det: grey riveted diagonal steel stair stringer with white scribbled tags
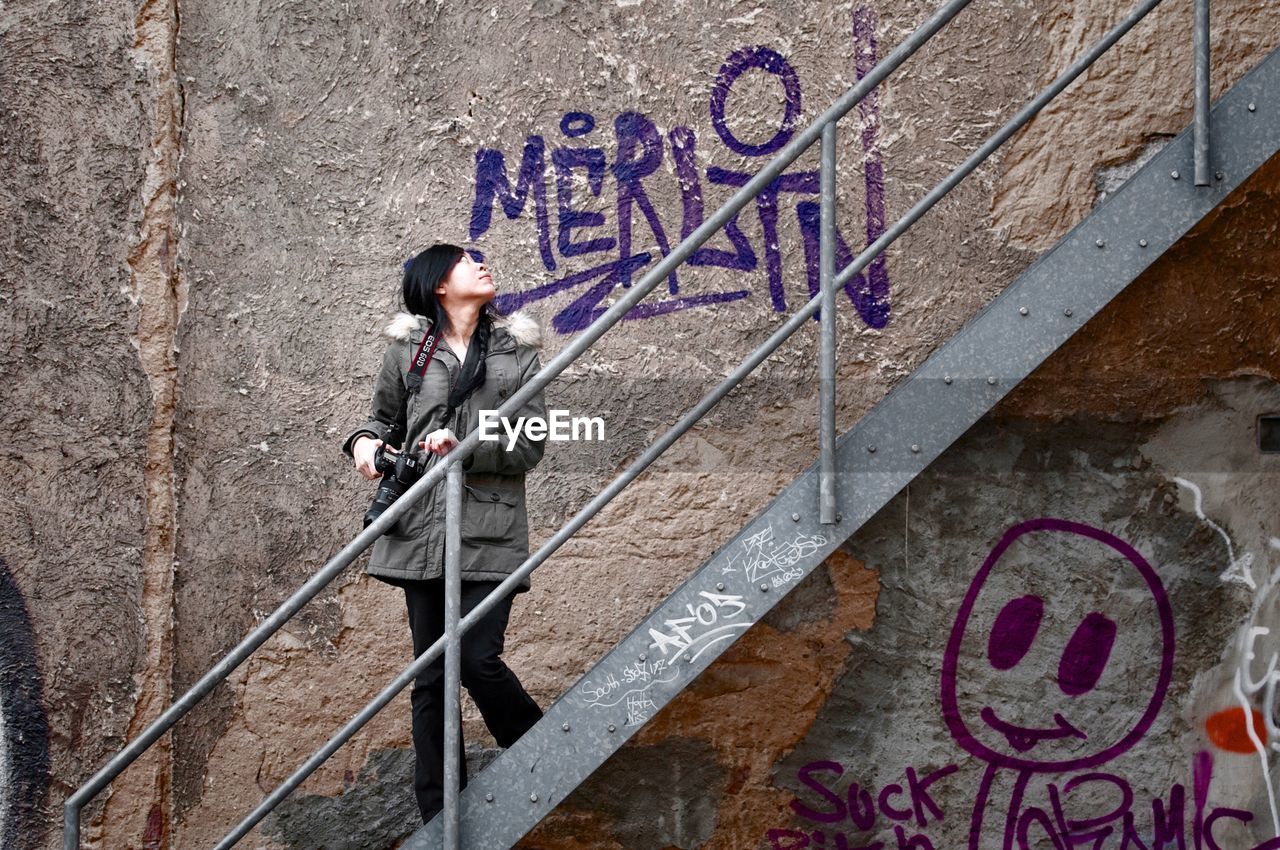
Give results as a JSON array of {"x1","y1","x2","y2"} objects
[{"x1": 403, "y1": 51, "x2": 1280, "y2": 850}]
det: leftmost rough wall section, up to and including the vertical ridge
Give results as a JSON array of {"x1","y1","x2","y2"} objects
[{"x1": 0, "y1": 3, "x2": 177, "y2": 846}]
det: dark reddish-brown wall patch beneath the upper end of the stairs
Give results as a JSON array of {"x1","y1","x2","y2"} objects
[{"x1": 998, "y1": 157, "x2": 1280, "y2": 419}]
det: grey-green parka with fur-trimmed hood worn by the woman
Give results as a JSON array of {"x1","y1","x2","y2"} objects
[{"x1": 342, "y1": 312, "x2": 547, "y2": 588}]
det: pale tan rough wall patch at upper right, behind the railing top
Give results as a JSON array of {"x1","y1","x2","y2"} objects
[{"x1": 991, "y1": 0, "x2": 1280, "y2": 251}]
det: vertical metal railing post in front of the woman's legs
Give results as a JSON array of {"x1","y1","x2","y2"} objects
[{"x1": 444, "y1": 461, "x2": 462, "y2": 850}]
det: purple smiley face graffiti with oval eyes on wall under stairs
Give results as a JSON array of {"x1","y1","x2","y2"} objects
[{"x1": 941, "y1": 518, "x2": 1174, "y2": 773}]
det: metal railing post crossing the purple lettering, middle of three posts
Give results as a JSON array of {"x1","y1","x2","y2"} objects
[{"x1": 818, "y1": 120, "x2": 836, "y2": 525}]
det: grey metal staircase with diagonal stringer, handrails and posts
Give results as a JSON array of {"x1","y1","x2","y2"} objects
[{"x1": 64, "y1": 0, "x2": 1280, "y2": 850}]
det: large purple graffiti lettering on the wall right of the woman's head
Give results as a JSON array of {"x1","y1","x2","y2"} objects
[{"x1": 470, "y1": 9, "x2": 890, "y2": 334}]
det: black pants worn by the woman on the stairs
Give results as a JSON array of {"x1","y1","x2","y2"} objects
[{"x1": 404, "y1": 579, "x2": 543, "y2": 823}]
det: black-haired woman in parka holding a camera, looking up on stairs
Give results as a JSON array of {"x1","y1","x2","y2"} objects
[{"x1": 343, "y1": 245, "x2": 547, "y2": 823}]
